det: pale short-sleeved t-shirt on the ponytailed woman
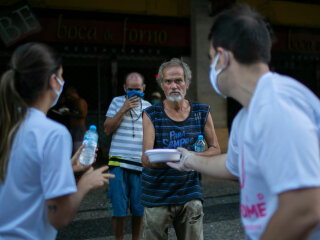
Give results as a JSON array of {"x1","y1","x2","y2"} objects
[{"x1": 0, "y1": 108, "x2": 77, "y2": 240}]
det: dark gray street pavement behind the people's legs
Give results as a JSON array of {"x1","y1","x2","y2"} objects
[{"x1": 57, "y1": 176, "x2": 245, "y2": 240}]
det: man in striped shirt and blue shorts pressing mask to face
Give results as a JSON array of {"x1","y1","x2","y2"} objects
[{"x1": 104, "y1": 72, "x2": 151, "y2": 240}]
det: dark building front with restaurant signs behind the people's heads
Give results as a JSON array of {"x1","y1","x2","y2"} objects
[{"x1": 0, "y1": 0, "x2": 320, "y2": 154}]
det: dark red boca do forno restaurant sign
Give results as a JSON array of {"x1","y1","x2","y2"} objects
[{"x1": 31, "y1": 14, "x2": 190, "y2": 48}]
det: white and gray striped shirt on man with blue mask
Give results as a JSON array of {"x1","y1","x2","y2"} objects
[{"x1": 106, "y1": 96, "x2": 151, "y2": 171}]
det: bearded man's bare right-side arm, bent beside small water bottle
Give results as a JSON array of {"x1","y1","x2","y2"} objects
[{"x1": 197, "y1": 113, "x2": 221, "y2": 156}]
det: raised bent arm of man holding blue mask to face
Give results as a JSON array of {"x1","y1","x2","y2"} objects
[{"x1": 103, "y1": 96, "x2": 141, "y2": 135}]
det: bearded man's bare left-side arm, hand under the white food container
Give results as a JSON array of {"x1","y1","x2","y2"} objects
[{"x1": 141, "y1": 113, "x2": 167, "y2": 168}]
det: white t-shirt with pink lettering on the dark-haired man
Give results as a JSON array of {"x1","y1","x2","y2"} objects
[{"x1": 226, "y1": 72, "x2": 320, "y2": 239}]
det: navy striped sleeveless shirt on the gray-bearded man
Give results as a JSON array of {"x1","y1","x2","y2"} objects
[{"x1": 141, "y1": 101, "x2": 210, "y2": 207}]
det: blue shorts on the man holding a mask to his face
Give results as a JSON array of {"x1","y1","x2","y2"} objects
[{"x1": 108, "y1": 167, "x2": 144, "y2": 217}]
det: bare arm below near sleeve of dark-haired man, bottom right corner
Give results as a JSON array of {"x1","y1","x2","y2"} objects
[{"x1": 261, "y1": 188, "x2": 320, "y2": 240}]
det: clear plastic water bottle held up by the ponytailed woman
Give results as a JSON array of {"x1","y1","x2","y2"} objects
[{"x1": 80, "y1": 125, "x2": 98, "y2": 165}]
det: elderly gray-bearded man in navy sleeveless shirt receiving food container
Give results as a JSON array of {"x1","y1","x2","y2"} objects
[{"x1": 141, "y1": 58, "x2": 220, "y2": 240}]
